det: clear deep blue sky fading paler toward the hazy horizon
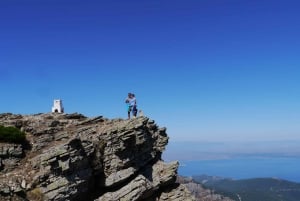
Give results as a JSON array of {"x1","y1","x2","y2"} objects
[{"x1": 0, "y1": 0, "x2": 300, "y2": 144}]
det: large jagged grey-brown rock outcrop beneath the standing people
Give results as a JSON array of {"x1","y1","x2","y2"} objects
[{"x1": 0, "y1": 113, "x2": 194, "y2": 201}]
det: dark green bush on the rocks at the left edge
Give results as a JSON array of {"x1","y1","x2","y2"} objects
[{"x1": 0, "y1": 126, "x2": 26, "y2": 143}]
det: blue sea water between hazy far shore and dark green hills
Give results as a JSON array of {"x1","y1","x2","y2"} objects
[{"x1": 178, "y1": 157, "x2": 300, "y2": 183}]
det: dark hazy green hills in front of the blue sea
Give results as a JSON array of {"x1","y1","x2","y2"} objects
[{"x1": 192, "y1": 175, "x2": 300, "y2": 201}]
